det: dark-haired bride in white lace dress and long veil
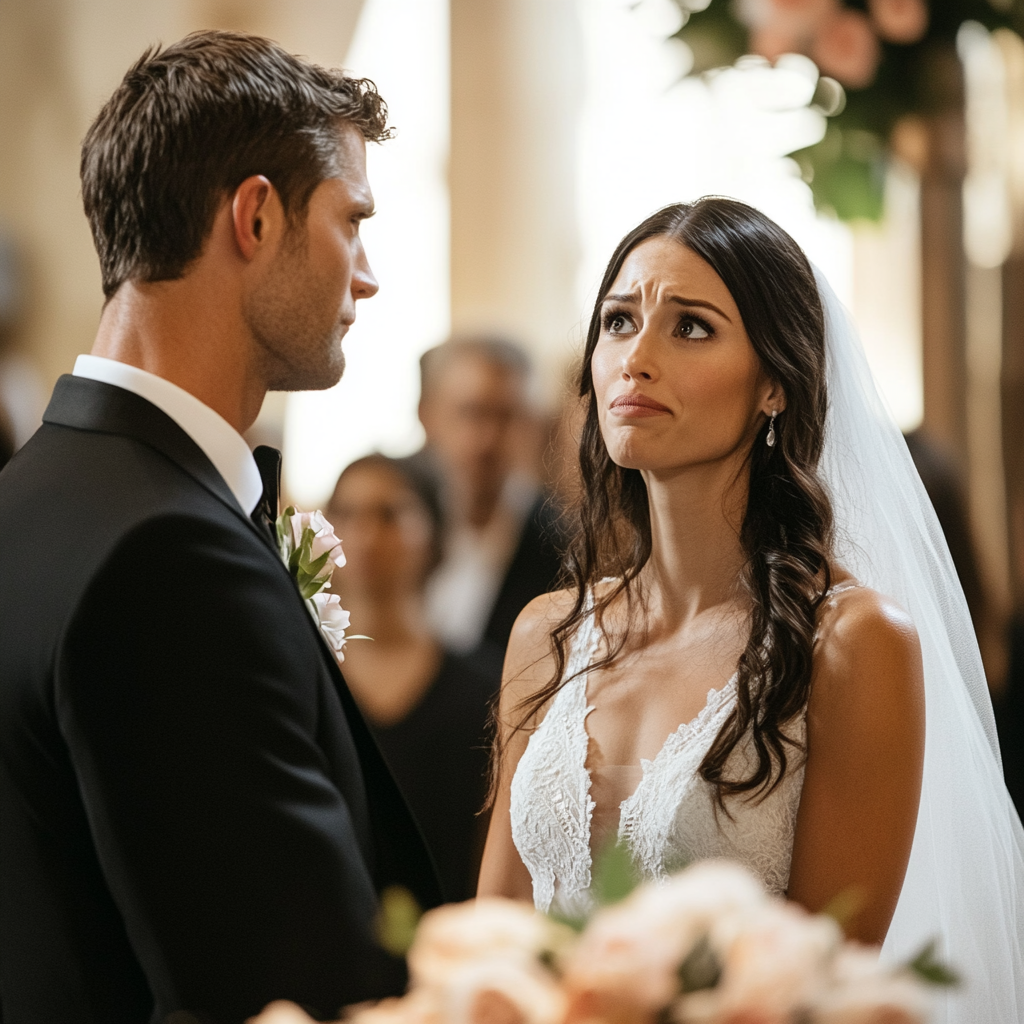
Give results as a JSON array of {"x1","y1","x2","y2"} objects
[{"x1": 479, "y1": 199, "x2": 1024, "y2": 1024}]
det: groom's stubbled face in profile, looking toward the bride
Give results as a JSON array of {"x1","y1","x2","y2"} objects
[{"x1": 244, "y1": 126, "x2": 378, "y2": 391}]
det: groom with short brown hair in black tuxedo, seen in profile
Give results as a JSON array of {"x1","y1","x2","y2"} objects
[{"x1": 0, "y1": 33, "x2": 437, "y2": 1024}]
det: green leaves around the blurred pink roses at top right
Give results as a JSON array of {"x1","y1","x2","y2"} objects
[{"x1": 676, "y1": 0, "x2": 1024, "y2": 220}]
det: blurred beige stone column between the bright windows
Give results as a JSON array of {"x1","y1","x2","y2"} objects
[{"x1": 450, "y1": 0, "x2": 584, "y2": 396}]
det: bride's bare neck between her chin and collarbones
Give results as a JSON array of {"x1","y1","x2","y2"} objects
[{"x1": 643, "y1": 463, "x2": 748, "y2": 620}]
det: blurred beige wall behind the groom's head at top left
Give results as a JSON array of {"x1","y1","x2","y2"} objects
[{"x1": 0, "y1": 0, "x2": 362, "y2": 388}]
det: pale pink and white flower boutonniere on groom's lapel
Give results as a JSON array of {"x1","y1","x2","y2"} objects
[{"x1": 278, "y1": 505, "x2": 362, "y2": 662}]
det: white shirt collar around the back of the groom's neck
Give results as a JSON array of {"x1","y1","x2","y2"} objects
[{"x1": 75, "y1": 355, "x2": 263, "y2": 515}]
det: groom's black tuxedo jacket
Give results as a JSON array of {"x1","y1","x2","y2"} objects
[{"x1": 0, "y1": 377, "x2": 438, "y2": 1024}]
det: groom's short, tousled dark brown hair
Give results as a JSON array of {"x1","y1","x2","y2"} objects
[{"x1": 81, "y1": 32, "x2": 389, "y2": 298}]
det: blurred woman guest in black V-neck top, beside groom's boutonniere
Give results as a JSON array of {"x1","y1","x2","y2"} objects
[{"x1": 327, "y1": 455, "x2": 496, "y2": 900}]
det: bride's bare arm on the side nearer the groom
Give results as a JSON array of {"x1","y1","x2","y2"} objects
[{"x1": 477, "y1": 594, "x2": 565, "y2": 902}]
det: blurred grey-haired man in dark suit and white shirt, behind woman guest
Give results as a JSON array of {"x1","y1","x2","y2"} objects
[{"x1": 416, "y1": 337, "x2": 560, "y2": 674}]
